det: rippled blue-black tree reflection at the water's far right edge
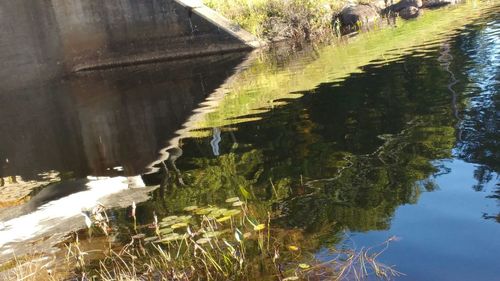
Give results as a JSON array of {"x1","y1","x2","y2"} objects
[{"x1": 456, "y1": 19, "x2": 500, "y2": 221}]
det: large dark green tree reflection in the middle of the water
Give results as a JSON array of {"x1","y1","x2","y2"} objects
[{"x1": 138, "y1": 49, "x2": 459, "y2": 245}]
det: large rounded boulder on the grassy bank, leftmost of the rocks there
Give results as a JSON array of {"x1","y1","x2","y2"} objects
[{"x1": 338, "y1": 4, "x2": 380, "y2": 28}]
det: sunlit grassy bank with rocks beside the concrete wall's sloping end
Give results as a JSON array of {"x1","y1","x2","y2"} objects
[{"x1": 203, "y1": 0, "x2": 459, "y2": 43}]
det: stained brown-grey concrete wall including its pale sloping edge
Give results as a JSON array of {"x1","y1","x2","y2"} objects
[{"x1": 0, "y1": 0, "x2": 260, "y2": 82}]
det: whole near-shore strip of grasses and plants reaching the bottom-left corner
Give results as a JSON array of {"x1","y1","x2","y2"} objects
[{"x1": 0, "y1": 200, "x2": 403, "y2": 281}]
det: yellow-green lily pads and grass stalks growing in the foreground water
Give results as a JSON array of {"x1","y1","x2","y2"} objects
[{"x1": 58, "y1": 197, "x2": 400, "y2": 280}]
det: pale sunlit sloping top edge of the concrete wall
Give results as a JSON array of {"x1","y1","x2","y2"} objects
[{"x1": 174, "y1": 0, "x2": 266, "y2": 49}]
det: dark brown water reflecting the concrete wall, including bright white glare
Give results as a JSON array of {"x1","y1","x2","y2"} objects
[{"x1": 0, "y1": 53, "x2": 246, "y2": 261}]
